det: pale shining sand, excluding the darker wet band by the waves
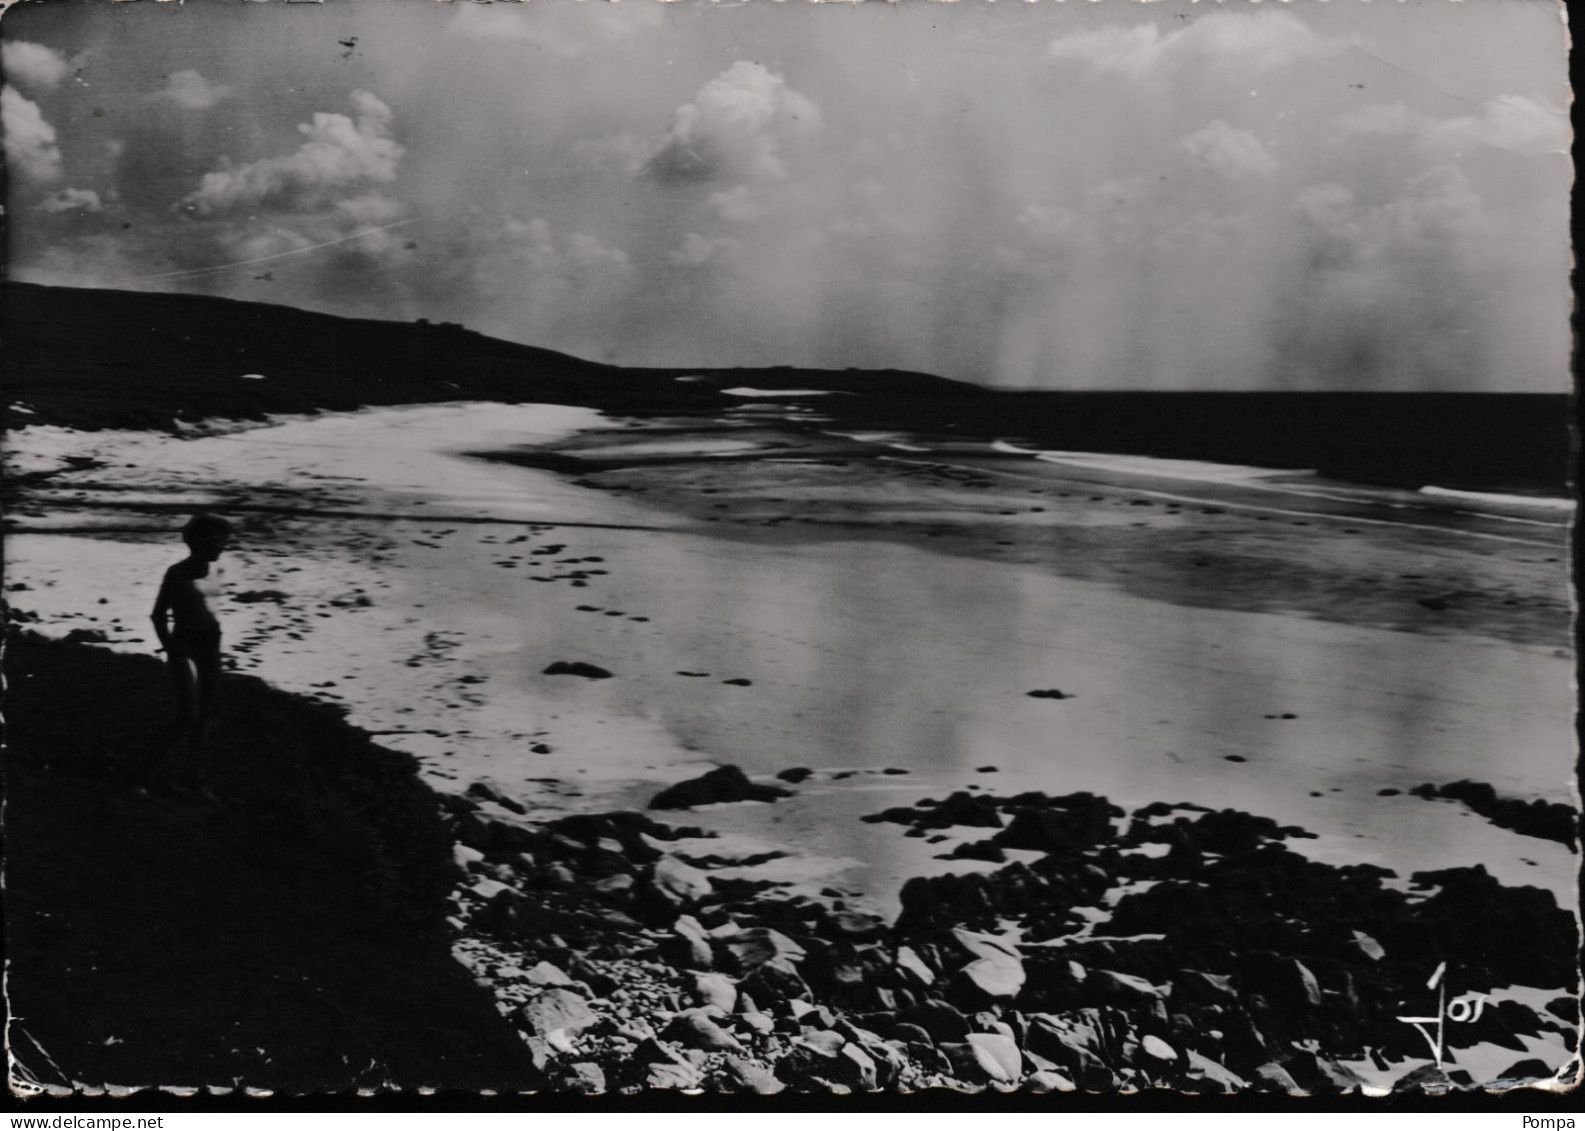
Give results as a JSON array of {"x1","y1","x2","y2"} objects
[{"x1": 8, "y1": 407, "x2": 1572, "y2": 918}]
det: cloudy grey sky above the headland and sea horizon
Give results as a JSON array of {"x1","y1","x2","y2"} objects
[{"x1": 0, "y1": 0, "x2": 1572, "y2": 391}]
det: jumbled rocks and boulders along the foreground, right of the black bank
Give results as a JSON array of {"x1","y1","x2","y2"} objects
[{"x1": 442, "y1": 767, "x2": 1579, "y2": 1095}]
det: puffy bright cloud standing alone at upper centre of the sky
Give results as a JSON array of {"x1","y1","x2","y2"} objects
[{"x1": 647, "y1": 62, "x2": 821, "y2": 181}]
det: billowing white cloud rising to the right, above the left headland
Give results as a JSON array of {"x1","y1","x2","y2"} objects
[{"x1": 181, "y1": 90, "x2": 404, "y2": 217}]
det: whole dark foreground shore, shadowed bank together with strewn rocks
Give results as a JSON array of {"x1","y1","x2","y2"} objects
[{"x1": 5, "y1": 632, "x2": 1579, "y2": 1095}]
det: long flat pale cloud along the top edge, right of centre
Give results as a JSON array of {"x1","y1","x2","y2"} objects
[{"x1": 1046, "y1": 11, "x2": 1342, "y2": 79}]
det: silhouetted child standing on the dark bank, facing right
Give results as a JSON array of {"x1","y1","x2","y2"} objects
[{"x1": 144, "y1": 513, "x2": 231, "y2": 798}]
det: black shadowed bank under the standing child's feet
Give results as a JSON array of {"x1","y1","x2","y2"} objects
[{"x1": 5, "y1": 635, "x2": 537, "y2": 1093}]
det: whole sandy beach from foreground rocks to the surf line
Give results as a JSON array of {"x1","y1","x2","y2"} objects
[{"x1": 10, "y1": 406, "x2": 1574, "y2": 904}]
